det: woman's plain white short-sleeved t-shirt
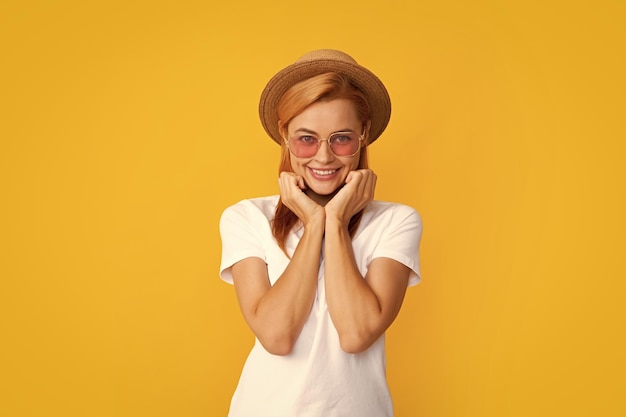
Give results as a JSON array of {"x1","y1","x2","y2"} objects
[{"x1": 220, "y1": 196, "x2": 422, "y2": 417}]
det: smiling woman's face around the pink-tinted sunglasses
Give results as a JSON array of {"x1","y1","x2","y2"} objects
[{"x1": 287, "y1": 99, "x2": 363, "y2": 204}]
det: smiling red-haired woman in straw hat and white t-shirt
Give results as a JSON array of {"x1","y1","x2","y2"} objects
[{"x1": 220, "y1": 50, "x2": 422, "y2": 417}]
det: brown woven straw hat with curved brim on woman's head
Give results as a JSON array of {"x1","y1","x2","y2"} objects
[{"x1": 259, "y1": 49, "x2": 391, "y2": 144}]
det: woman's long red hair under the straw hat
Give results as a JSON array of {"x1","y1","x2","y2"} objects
[{"x1": 272, "y1": 72, "x2": 370, "y2": 257}]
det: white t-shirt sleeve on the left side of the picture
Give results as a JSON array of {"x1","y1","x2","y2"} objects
[{"x1": 220, "y1": 200, "x2": 265, "y2": 284}]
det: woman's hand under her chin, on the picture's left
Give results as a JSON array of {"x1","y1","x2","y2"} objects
[{"x1": 278, "y1": 171, "x2": 326, "y2": 226}]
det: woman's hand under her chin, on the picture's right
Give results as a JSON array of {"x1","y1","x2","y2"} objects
[{"x1": 325, "y1": 169, "x2": 376, "y2": 226}]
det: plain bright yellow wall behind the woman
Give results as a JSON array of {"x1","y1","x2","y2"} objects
[{"x1": 0, "y1": 0, "x2": 626, "y2": 417}]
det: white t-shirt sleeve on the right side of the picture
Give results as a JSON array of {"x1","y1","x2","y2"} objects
[{"x1": 372, "y1": 205, "x2": 422, "y2": 287}]
